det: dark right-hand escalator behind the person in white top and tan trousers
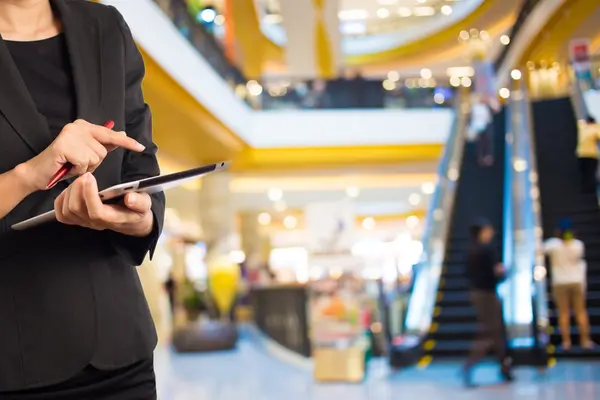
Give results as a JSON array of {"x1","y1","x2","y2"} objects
[{"x1": 532, "y1": 98, "x2": 600, "y2": 358}]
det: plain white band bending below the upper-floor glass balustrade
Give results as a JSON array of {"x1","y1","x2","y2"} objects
[{"x1": 102, "y1": 0, "x2": 452, "y2": 147}]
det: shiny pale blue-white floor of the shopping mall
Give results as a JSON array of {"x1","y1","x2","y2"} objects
[{"x1": 156, "y1": 340, "x2": 600, "y2": 400}]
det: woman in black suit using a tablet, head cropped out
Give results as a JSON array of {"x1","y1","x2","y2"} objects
[{"x1": 0, "y1": 0, "x2": 164, "y2": 400}]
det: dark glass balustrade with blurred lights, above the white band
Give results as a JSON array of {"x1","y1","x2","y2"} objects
[{"x1": 154, "y1": 0, "x2": 456, "y2": 110}]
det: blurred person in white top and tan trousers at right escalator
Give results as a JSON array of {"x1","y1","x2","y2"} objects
[{"x1": 544, "y1": 220, "x2": 594, "y2": 350}]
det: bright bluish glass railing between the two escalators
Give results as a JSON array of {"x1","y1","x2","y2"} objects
[{"x1": 503, "y1": 81, "x2": 548, "y2": 353}]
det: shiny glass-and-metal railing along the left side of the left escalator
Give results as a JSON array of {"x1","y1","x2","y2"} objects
[{"x1": 405, "y1": 89, "x2": 469, "y2": 336}]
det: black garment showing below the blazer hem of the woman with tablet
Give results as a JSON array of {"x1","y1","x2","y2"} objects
[{"x1": 0, "y1": 360, "x2": 157, "y2": 400}]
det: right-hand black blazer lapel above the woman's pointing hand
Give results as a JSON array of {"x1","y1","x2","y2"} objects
[{"x1": 51, "y1": 0, "x2": 105, "y2": 124}]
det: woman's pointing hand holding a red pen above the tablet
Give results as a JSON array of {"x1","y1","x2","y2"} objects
[{"x1": 21, "y1": 119, "x2": 144, "y2": 191}]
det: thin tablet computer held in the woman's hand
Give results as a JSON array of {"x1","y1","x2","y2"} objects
[{"x1": 11, "y1": 161, "x2": 230, "y2": 231}]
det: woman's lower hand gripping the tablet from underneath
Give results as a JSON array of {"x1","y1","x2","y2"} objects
[{"x1": 54, "y1": 173, "x2": 154, "y2": 237}]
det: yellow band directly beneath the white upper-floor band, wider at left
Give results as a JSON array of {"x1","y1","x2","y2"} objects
[{"x1": 141, "y1": 45, "x2": 443, "y2": 171}]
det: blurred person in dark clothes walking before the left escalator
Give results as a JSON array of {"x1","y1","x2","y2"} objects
[{"x1": 462, "y1": 220, "x2": 513, "y2": 387}]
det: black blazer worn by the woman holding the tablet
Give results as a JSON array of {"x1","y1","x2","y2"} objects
[{"x1": 0, "y1": 0, "x2": 165, "y2": 390}]
